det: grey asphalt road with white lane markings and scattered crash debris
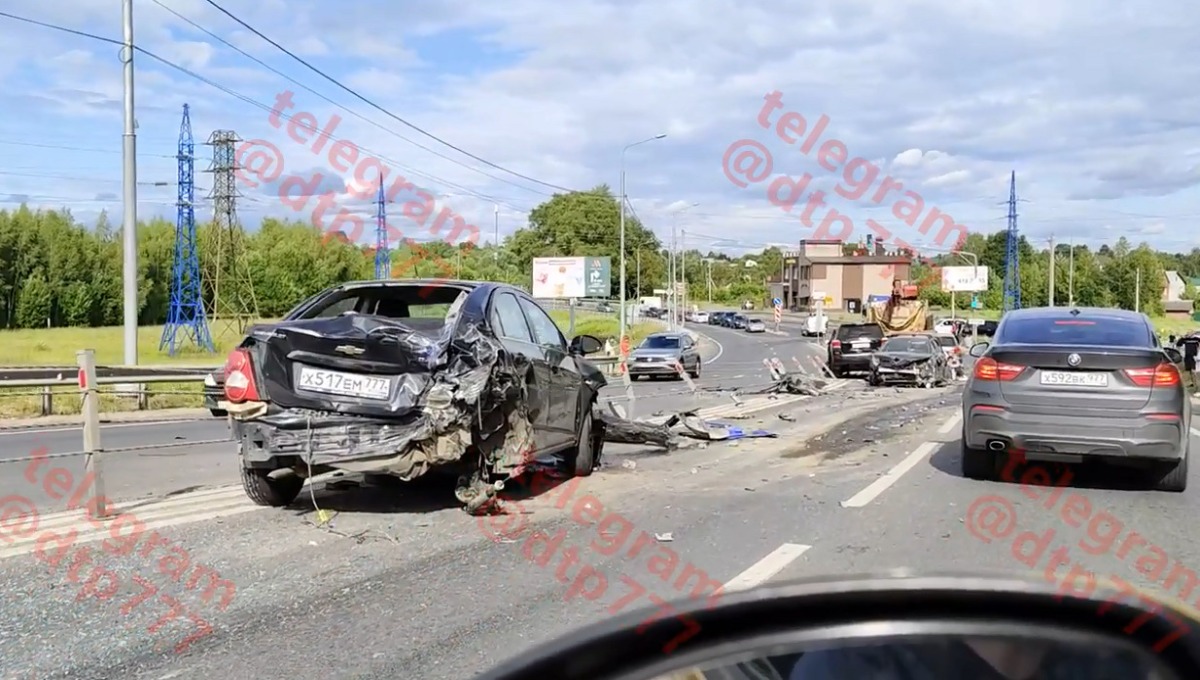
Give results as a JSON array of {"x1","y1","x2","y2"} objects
[{"x1": 0, "y1": 329, "x2": 1065, "y2": 680}]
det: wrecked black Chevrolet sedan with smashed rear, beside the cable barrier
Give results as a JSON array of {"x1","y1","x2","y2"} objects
[{"x1": 220, "y1": 281, "x2": 606, "y2": 511}]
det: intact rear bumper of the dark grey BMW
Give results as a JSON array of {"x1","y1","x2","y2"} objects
[{"x1": 962, "y1": 408, "x2": 1188, "y2": 461}]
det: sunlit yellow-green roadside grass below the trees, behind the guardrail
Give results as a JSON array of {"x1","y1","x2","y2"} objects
[{"x1": 0, "y1": 311, "x2": 659, "y2": 417}]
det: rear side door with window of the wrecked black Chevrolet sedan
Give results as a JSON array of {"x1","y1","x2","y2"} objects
[{"x1": 488, "y1": 290, "x2": 559, "y2": 452}]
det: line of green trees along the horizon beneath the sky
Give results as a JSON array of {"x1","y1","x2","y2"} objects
[{"x1": 0, "y1": 186, "x2": 1200, "y2": 329}]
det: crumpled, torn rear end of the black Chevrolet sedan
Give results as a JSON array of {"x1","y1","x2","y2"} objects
[{"x1": 238, "y1": 315, "x2": 533, "y2": 480}]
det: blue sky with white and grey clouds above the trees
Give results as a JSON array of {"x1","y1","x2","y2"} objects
[{"x1": 0, "y1": 0, "x2": 1200, "y2": 257}]
